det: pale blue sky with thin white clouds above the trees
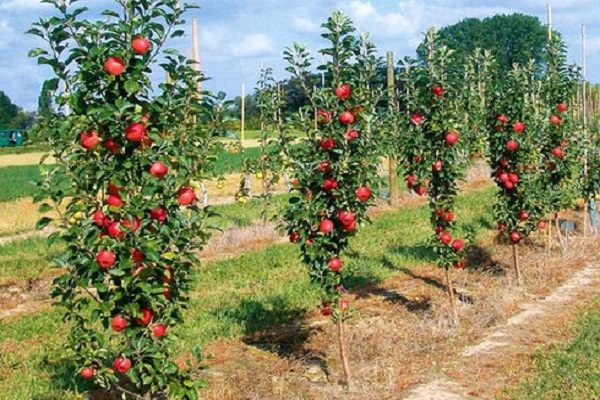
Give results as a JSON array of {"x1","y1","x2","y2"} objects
[{"x1": 0, "y1": 0, "x2": 600, "y2": 111}]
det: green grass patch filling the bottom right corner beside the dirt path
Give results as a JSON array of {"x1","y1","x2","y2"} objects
[{"x1": 506, "y1": 297, "x2": 600, "y2": 400}]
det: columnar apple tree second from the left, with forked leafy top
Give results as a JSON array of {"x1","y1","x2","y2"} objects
[{"x1": 284, "y1": 12, "x2": 384, "y2": 380}]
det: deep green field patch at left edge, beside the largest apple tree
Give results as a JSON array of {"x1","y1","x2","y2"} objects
[{"x1": 0, "y1": 165, "x2": 41, "y2": 202}]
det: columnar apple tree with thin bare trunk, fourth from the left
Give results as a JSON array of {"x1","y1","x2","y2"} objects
[{"x1": 488, "y1": 62, "x2": 547, "y2": 282}]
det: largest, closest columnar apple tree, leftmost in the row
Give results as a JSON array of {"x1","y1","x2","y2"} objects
[{"x1": 30, "y1": 0, "x2": 217, "y2": 398}]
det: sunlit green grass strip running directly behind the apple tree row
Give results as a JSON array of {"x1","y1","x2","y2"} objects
[{"x1": 0, "y1": 189, "x2": 494, "y2": 400}]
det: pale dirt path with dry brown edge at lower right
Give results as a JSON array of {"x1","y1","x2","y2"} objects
[{"x1": 402, "y1": 263, "x2": 600, "y2": 400}]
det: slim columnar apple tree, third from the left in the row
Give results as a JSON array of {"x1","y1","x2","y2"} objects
[{"x1": 399, "y1": 30, "x2": 466, "y2": 317}]
